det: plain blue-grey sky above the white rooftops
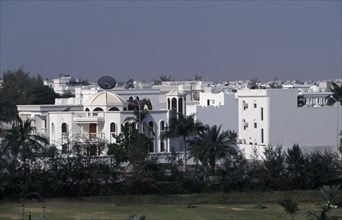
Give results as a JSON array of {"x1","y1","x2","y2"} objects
[{"x1": 0, "y1": 0, "x2": 342, "y2": 81}]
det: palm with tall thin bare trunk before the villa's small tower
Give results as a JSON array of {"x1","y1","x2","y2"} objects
[{"x1": 162, "y1": 113, "x2": 203, "y2": 172}]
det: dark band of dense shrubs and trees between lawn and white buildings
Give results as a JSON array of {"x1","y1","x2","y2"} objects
[{"x1": 0, "y1": 117, "x2": 342, "y2": 198}]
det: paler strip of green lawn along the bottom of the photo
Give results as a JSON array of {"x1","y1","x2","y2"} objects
[{"x1": 0, "y1": 201, "x2": 342, "y2": 220}]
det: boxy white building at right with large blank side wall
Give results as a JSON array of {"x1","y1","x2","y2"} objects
[{"x1": 237, "y1": 89, "x2": 342, "y2": 155}]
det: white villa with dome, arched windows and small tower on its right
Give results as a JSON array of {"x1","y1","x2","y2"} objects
[{"x1": 17, "y1": 82, "x2": 212, "y2": 155}]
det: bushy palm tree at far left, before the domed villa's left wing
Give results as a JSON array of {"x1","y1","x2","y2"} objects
[{"x1": 4, "y1": 116, "x2": 48, "y2": 175}]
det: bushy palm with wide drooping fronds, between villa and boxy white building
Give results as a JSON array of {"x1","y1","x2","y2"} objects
[{"x1": 189, "y1": 125, "x2": 237, "y2": 171}]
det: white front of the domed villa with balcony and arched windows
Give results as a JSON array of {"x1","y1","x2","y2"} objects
[{"x1": 18, "y1": 91, "x2": 174, "y2": 153}]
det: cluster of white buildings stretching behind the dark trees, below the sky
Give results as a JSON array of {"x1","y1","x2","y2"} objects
[{"x1": 13, "y1": 76, "x2": 342, "y2": 157}]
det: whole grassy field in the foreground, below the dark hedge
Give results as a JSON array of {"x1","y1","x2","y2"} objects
[{"x1": 0, "y1": 192, "x2": 342, "y2": 220}]
